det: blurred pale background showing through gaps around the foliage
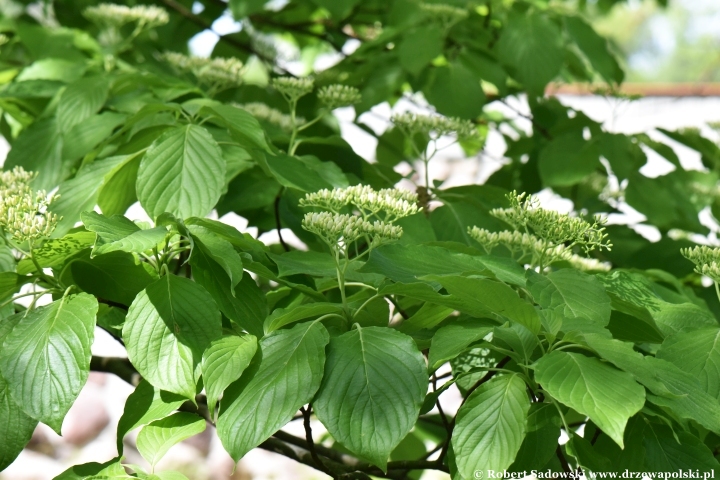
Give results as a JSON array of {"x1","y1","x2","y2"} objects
[{"x1": 0, "y1": 0, "x2": 720, "y2": 480}]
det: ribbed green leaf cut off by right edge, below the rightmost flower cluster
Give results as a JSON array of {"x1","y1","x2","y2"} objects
[{"x1": 656, "y1": 327, "x2": 720, "y2": 399}]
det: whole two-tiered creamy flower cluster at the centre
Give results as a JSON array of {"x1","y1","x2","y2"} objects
[{"x1": 300, "y1": 185, "x2": 419, "y2": 251}]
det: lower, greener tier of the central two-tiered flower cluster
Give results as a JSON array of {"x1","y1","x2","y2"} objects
[{"x1": 302, "y1": 212, "x2": 402, "y2": 246}]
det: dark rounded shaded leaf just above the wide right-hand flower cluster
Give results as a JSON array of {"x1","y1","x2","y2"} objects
[{"x1": 538, "y1": 131, "x2": 601, "y2": 187}]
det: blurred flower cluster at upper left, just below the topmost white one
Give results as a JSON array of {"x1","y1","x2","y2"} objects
[{"x1": 162, "y1": 52, "x2": 244, "y2": 89}]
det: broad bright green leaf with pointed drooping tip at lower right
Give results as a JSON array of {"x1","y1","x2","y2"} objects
[{"x1": 535, "y1": 351, "x2": 645, "y2": 448}]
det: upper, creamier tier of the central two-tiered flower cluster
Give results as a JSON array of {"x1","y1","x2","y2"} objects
[{"x1": 300, "y1": 185, "x2": 420, "y2": 221}]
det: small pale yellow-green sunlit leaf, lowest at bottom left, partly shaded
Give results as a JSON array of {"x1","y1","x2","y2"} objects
[{"x1": 137, "y1": 412, "x2": 205, "y2": 467}]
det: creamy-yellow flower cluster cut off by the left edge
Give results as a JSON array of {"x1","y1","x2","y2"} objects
[{"x1": 0, "y1": 167, "x2": 59, "y2": 242}]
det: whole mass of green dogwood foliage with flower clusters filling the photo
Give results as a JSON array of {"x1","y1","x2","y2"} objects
[{"x1": 0, "y1": 0, "x2": 720, "y2": 479}]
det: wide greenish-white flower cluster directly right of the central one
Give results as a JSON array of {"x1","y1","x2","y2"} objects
[{"x1": 468, "y1": 192, "x2": 612, "y2": 270}]
